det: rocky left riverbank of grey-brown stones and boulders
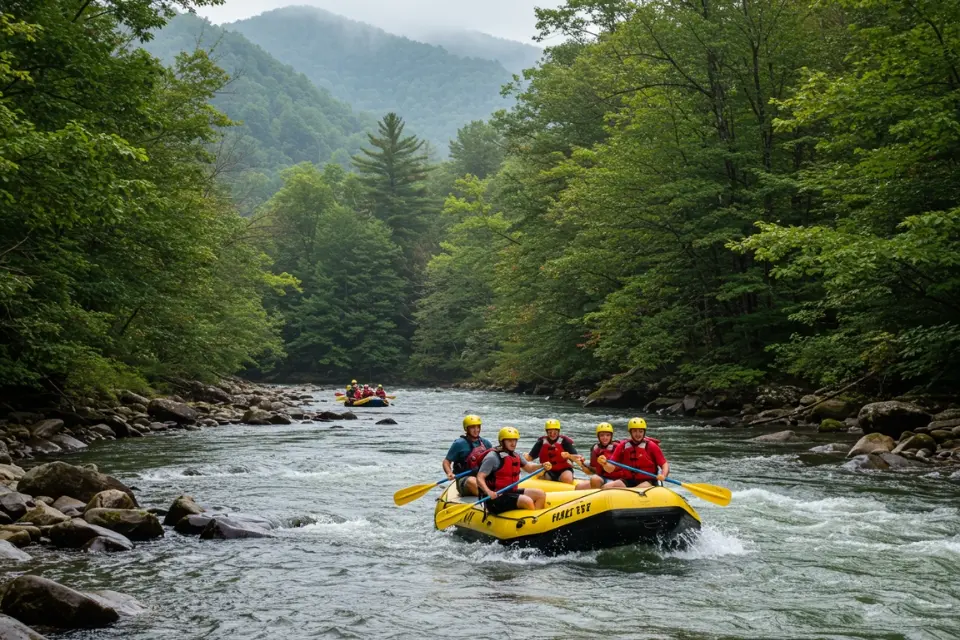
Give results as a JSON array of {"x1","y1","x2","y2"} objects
[{"x1": 0, "y1": 380, "x2": 356, "y2": 640}]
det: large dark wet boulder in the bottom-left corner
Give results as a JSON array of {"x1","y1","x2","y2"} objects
[{"x1": 0, "y1": 575, "x2": 120, "y2": 629}]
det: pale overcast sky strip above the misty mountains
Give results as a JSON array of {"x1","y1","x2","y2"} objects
[{"x1": 200, "y1": 0, "x2": 563, "y2": 42}]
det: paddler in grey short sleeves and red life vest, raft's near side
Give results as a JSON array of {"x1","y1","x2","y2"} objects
[{"x1": 477, "y1": 427, "x2": 550, "y2": 513}]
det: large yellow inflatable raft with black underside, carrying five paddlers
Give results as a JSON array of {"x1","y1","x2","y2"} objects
[{"x1": 434, "y1": 478, "x2": 700, "y2": 553}]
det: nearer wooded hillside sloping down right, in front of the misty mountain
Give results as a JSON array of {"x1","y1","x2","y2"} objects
[{"x1": 144, "y1": 14, "x2": 375, "y2": 192}]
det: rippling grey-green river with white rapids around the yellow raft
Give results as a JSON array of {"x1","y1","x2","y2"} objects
[{"x1": 15, "y1": 390, "x2": 960, "y2": 640}]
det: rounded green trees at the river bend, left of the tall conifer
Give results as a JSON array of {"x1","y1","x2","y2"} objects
[{"x1": 265, "y1": 164, "x2": 408, "y2": 378}]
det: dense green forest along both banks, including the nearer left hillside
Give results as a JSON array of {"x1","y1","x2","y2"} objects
[{"x1": 0, "y1": 0, "x2": 960, "y2": 395}]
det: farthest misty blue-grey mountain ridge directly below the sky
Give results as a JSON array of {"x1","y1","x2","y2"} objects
[{"x1": 228, "y1": 7, "x2": 511, "y2": 151}]
